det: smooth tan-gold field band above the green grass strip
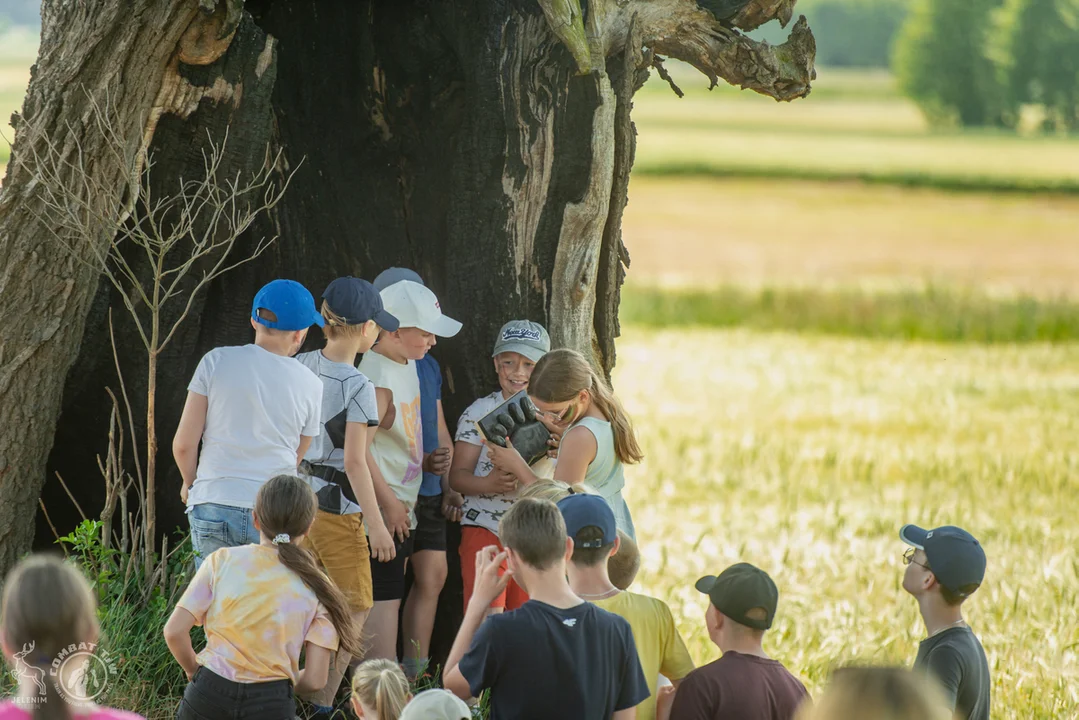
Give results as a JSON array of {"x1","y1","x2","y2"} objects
[{"x1": 623, "y1": 176, "x2": 1079, "y2": 297}]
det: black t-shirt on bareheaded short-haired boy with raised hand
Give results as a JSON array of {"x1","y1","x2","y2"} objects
[{"x1": 460, "y1": 600, "x2": 648, "y2": 720}]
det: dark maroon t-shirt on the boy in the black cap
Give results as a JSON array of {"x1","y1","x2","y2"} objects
[{"x1": 671, "y1": 652, "x2": 809, "y2": 720}]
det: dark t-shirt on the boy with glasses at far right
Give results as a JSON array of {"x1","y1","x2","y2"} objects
[{"x1": 914, "y1": 627, "x2": 989, "y2": 720}]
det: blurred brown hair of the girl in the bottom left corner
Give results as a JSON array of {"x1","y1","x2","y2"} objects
[{"x1": 0, "y1": 555, "x2": 98, "y2": 720}]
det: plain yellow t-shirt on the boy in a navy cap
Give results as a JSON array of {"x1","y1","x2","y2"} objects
[{"x1": 595, "y1": 592, "x2": 694, "y2": 720}]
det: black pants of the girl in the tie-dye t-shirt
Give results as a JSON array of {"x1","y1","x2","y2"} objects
[{"x1": 176, "y1": 667, "x2": 296, "y2": 720}]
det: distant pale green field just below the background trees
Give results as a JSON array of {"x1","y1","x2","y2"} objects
[{"x1": 633, "y1": 65, "x2": 1079, "y2": 192}]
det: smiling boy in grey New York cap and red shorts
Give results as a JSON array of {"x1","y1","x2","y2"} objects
[{"x1": 450, "y1": 320, "x2": 550, "y2": 614}]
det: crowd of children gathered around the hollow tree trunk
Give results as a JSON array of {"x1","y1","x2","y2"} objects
[{"x1": 0, "y1": 268, "x2": 988, "y2": 720}]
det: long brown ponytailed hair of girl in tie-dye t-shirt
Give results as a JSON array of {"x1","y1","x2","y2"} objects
[{"x1": 255, "y1": 475, "x2": 363, "y2": 656}]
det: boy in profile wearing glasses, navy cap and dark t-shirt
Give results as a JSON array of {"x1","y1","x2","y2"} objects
[{"x1": 899, "y1": 525, "x2": 989, "y2": 720}]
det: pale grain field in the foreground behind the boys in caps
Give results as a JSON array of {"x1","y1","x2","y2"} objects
[{"x1": 615, "y1": 327, "x2": 1079, "y2": 719}]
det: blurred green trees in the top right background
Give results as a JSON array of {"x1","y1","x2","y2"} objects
[{"x1": 762, "y1": 0, "x2": 1079, "y2": 132}]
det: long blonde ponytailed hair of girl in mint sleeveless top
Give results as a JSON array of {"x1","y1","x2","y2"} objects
[{"x1": 529, "y1": 348, "x2": 644, "y2": 464}]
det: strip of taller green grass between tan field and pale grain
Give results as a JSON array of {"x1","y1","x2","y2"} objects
[{"x1": 619, "y1": 285, "x2": 1079, "y2": 343}]
